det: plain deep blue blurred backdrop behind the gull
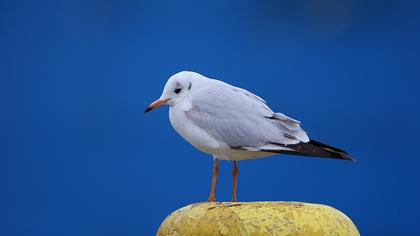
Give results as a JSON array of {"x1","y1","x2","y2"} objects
[{"x1": 0, "y1": 0, "x2": 420, "y2": 235}]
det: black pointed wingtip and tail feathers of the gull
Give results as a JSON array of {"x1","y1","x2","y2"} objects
[{"x1": 264, "y1": 140, "x2": 356, "y2": 161}]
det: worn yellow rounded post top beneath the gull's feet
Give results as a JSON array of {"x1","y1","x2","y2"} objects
[{"x1": 157, "y1": 202, "x2": 360, "y2": 236}]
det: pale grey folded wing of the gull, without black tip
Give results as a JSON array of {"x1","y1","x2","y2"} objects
[{"x1": 186, "y1": 84, "x2": 309, "y2": 151}]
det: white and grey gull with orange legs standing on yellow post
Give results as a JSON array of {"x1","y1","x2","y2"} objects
[{"x1": 144, "y1": 71, "x2": 355, "y2": 202}]
